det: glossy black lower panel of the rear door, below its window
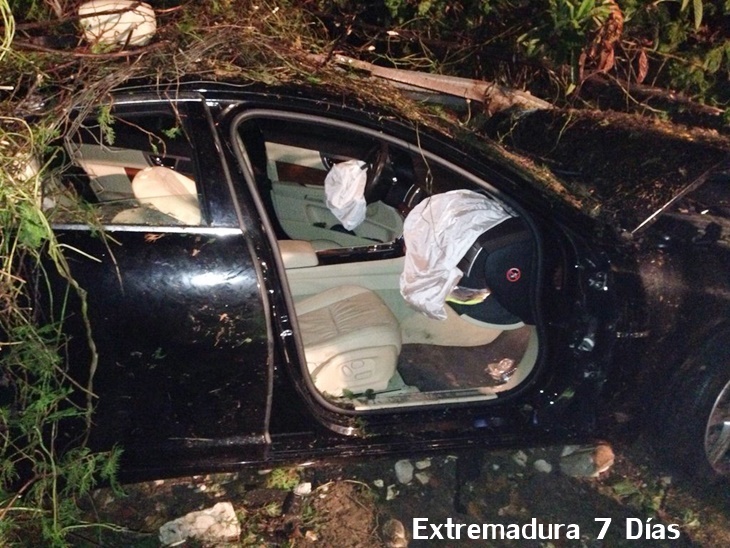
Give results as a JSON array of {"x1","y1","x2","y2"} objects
[{"x1": 49, "y1": 230, "x2": 269, "y2": 466}]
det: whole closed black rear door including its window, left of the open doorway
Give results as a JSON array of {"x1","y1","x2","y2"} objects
[{"x1": 45, "y1": 97, "x2": 271, "y2": 475}]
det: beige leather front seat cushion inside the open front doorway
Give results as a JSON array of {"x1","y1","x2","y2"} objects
[{"x1": 296, "y1": 285, "x2": 401, "y2": 396}]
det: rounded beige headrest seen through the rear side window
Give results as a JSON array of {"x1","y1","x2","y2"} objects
[{"x1": 132, "y1": 166, "x2": 201, "y2": 226}]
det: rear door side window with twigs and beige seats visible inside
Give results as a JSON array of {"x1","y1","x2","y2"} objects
[{"x1": 44, "y1": 109, "x2": 203, "y2": 226}]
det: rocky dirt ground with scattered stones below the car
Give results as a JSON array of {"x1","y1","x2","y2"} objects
[{"x1": 75, "y1": 436, "x2": 730, "y2": 548}]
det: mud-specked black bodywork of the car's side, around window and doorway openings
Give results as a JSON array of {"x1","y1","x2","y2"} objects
[{"x1": 37, "y1": 85, "x2": 730, "y2": 479}]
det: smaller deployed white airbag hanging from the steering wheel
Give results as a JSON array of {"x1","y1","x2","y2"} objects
[{"x1": 324, "y1": 160, "x2": 367, "y2": 230}]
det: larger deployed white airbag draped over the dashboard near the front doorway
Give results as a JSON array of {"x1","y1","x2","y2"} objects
[{"x1": 400, "y1": 190, "x2": 511, "y2": 320}]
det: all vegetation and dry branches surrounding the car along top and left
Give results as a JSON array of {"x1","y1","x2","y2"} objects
[{"x1": 0, "y1": 0, "x2": 730, "y2": 546}]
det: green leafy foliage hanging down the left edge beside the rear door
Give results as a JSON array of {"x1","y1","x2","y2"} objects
[{"x1": 0, "y1": 77, "x2": 119, "y2": 546}]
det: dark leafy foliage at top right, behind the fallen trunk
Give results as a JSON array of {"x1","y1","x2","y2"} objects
[{"x1": 315, "y1": 0, "x2": 730, "y2": 106}]
